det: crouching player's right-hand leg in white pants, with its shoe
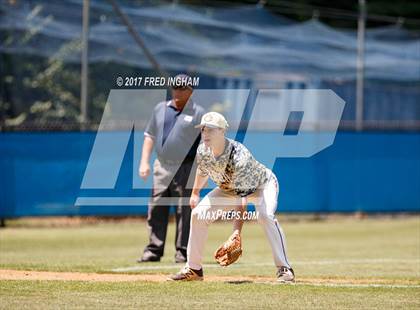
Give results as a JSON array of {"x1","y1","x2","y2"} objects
[{"x1": 251, "y1": 173, "x2": 294, "y2": 282}]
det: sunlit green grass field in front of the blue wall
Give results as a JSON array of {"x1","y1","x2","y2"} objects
[{"x1": 0, "y1": 216, "x2": 420, "y2": 309}]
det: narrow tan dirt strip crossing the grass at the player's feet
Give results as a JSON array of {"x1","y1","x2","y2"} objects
[{"x1": 0, "y1": 269, "x2": 420, "y2": 288}]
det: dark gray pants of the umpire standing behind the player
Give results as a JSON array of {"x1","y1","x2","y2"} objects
[{"x1": 144, "y1": 159, "x2": 196, "y2": 259}]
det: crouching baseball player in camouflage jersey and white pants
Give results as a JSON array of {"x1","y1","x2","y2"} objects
[{"x1": 169, "y1": 112, "x2": 295, "y2": 282}]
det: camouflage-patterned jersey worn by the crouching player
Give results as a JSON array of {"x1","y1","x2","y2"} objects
[{"x1": 197, "y1": 138, "x2": 268, "y2": 197}]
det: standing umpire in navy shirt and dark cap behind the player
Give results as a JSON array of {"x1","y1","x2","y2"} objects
[{"x1": 137, "y1": 74, "x2": 204, "y2": 263}]
